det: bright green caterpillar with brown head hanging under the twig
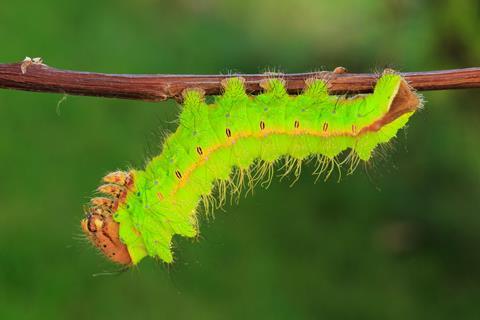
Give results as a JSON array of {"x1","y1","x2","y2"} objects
[{"x1": 81, "y1": 70, "x2": 422, "y2": 266}]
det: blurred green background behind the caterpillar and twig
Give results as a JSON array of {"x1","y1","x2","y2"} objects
[{"x1": 0, "y1": 0, "x2": 480, "y2": 319}]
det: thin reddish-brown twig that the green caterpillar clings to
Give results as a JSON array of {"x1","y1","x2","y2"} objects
[{"x1": 0, "y1": 58, "x2": 480, "y2": 101}]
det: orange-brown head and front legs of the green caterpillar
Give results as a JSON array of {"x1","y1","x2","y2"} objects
[{"x1": 81, "y1": 171, "x2": 132, "y2": 265}]
